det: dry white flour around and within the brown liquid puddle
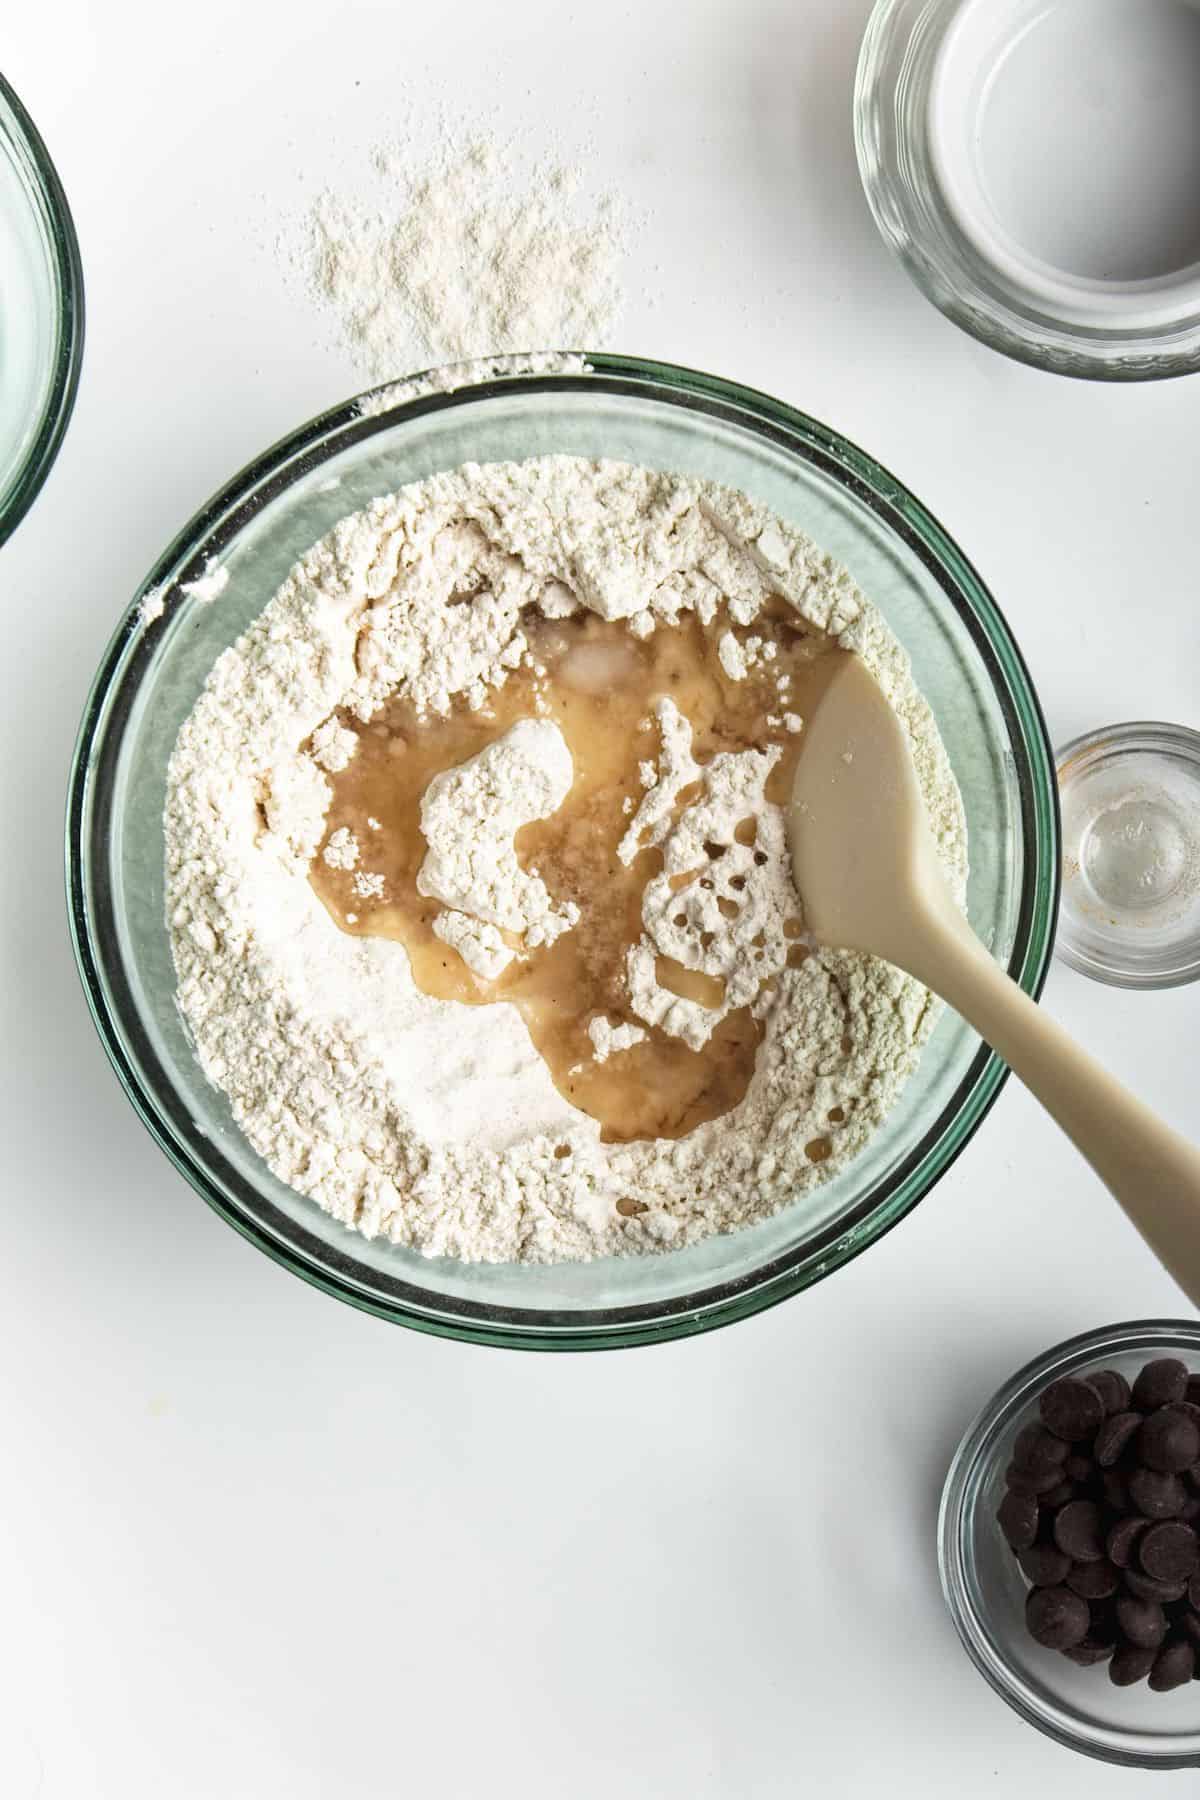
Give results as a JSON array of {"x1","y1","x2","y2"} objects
[{"x1": 166, "y1": 457, "x2": 966, "y2": 1262}]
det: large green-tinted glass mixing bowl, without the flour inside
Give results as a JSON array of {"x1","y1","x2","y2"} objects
[{"x1": 67, "y1": 356, "x2": 1060, "y2": 1348}]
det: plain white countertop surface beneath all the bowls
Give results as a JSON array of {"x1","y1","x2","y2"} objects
[{"x1": 0, "y1": 0, "x2": 1200, "y2": 1800}]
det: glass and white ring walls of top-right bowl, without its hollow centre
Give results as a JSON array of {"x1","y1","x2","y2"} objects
[{"x1": 855, "y1": 0, "x2": 1200, "y2": 382}]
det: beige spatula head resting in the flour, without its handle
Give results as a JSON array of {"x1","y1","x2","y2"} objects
[{"x1": 788, "y1": 655, "x2": 945, "y2": 965}]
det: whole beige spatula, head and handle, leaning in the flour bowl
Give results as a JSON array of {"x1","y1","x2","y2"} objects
[{"x1": 788, "y1": 657, "x2": 1200, "y2": 1305}]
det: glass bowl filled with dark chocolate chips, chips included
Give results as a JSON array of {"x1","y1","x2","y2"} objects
[{"x1": 937, "y1": 1321, "x2": 1200, "y2": 1768}]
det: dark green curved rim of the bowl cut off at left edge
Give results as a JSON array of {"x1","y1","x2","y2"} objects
[{"x1": 0, "y1": 76, "x2": 85, "y2": 544}]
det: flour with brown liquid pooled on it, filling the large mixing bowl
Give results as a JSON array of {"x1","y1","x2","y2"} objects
[{"x1": 166, "y1": 457, "x2": 966, "y2": 1262}]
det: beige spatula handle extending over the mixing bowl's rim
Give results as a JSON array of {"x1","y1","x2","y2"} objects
[{"x1": 910, "y1": 920, "x2": 1200, "y2": 1307}]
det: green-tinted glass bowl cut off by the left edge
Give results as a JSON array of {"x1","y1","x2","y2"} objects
[{"x1": 0, "y1": 76, "x2": 83, "y2": 544}]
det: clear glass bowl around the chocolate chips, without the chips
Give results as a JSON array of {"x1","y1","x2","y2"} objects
[{"x1": 937, "y1": 1319, "x2": 1200, "y2": 1769}]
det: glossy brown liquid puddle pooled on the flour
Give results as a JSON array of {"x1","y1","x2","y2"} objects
[{"x1": 309, "y1": 601, "x2": 844, "y2": 1137}]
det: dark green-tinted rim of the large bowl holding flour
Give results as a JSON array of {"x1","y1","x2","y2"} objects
[{"x1": 67, "y1": 355, "x2": 1060, "y2": 1350}]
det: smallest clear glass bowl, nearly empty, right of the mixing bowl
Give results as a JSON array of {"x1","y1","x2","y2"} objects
[{"x1": 1056, "y1": 724, "x2": 1200, "y2": 988}]
